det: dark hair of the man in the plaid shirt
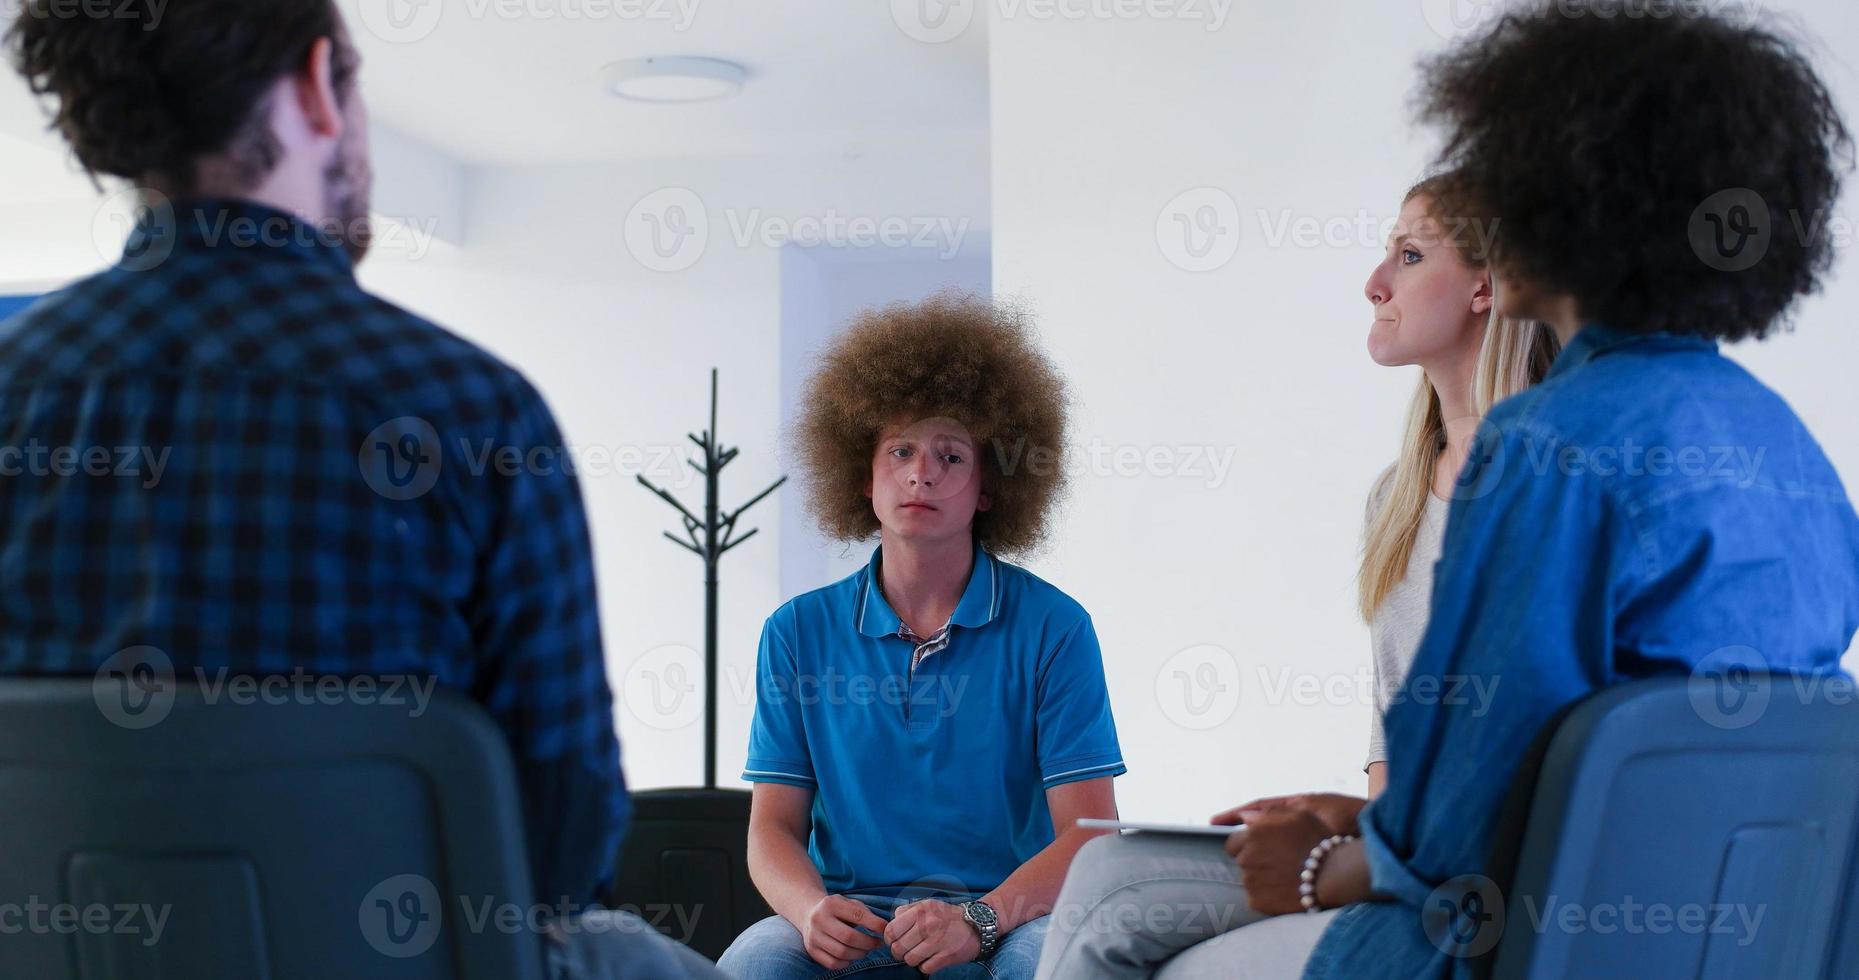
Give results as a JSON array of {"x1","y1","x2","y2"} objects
[{"x1": 6, "y1": 0, "x2": 357, "y2": 195}]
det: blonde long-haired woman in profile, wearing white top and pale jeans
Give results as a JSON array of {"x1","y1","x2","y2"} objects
[{"x1": 1037, "y1": 177, "x2": 1560, "y2": 980}]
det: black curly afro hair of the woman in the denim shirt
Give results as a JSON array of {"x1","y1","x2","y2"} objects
[{"x1": 1417, "y1": 0, "x2": 1852, "y2": 340}]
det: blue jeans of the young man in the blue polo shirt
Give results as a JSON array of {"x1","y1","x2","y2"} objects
[{"x1": 716, "y1": 894, "x2": 1047, "y2": 980}]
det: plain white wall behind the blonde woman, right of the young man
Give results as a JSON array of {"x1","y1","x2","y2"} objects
[{"x1": 989, "y1": 2, "x2": 1859, "y2": 820}]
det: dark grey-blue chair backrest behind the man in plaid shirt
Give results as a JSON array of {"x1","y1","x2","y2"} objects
[{"x1": 0, "y1": 675, "x2": 543, "y2": 980}]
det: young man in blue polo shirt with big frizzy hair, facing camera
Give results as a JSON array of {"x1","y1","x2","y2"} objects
[{"x1": 719, "y1": 296, "x2": 1125, "y2": 980}]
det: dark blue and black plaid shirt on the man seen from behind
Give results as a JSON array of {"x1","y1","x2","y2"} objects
[{"x1": 0, "y1": 201, "x2": 628, "y2": 904}]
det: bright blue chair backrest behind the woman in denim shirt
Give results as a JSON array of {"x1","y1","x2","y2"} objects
[{"x1": 1495, "y1": 675, "x2": 1859, "y2": 980}]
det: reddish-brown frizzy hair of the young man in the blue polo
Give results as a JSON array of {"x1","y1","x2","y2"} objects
[{"x1": 794, "y1": 294, "x2": 1065, "y2": 554}]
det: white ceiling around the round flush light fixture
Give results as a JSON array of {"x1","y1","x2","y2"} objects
[{"x1": 342, "y1": 0, "x2": 987, "y2": 166}]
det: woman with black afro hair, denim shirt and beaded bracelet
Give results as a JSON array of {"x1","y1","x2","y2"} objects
[{"x1": 1061, "y1": 0, "x2": 1859, "y2": 980}]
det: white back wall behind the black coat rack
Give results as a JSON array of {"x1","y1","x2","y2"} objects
[{"x1": 361, "y1": 147, "x2": 987, "y2": 788}]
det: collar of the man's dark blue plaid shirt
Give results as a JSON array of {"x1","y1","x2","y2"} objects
[{"x1": 123, "y1": 197, "x2": 355, "y2": 275}]
